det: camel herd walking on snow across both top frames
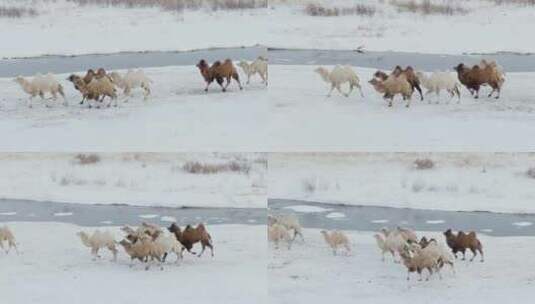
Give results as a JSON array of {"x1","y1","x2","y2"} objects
[{"x1": 11, "y1": 56, "x2": 505, "y2": 107}]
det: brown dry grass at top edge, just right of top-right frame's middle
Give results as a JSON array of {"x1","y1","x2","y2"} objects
[{"x1": 390, "y1": 0, "x2": 470, "y2": 16}]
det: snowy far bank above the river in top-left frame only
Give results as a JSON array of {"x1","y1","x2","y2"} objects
[{"x1": 0, "y1": 0, "x2": 268, "y2": 58}]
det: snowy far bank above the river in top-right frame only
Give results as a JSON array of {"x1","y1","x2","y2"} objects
[{"x1": 266, "y1": 0, "x2": 535, "y2": 54}]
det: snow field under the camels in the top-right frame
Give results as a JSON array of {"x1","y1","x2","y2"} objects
[{"x1": 268, "y1": 65, "x2": 535, "y2": 152}]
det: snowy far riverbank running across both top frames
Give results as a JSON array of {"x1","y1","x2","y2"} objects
[{"x1": 0, "y1": 0, "x2": 535, "y2": 58}]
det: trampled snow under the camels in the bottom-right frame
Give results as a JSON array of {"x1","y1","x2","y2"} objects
[{"x1": 268, "y1": 229, "x2": 535, "y2": 304}]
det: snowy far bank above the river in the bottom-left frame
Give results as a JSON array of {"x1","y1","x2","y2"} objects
[{"x1": 0, "y1": 153, "x2": 267, "y2": 208}]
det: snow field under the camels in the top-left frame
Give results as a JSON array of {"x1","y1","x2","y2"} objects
[{"x1": 0, "y1": 63, "x2": 268, "y2": 152}]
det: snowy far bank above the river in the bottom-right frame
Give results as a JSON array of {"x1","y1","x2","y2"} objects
[{"x1": 268, "y1": 153, "x2": 535, "y2": 213}]
